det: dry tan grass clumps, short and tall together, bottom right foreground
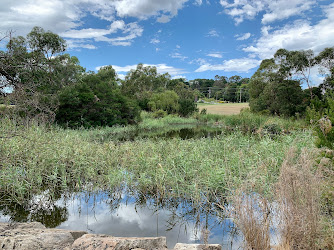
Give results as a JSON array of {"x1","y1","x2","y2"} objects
[{"x1": 230, "y1": 149, "x2": 334, "y2": 250}]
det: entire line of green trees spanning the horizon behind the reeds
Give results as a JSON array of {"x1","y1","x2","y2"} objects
[{"x1": 0, "y1": 27, "x2": 334, "y2": 127}]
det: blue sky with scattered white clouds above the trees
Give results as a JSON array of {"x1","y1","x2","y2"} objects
[{"x1": 0, "y1": 0, "x2": 334, "y2": 85}]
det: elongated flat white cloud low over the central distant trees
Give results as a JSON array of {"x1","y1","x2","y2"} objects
[{"x1": 195, "y1": 58, "x2": 261, "y2": 72}]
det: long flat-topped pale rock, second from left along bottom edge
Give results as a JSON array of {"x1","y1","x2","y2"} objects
[{"x1": 72, "y1": 234, "x2": 167, "y2": 250}]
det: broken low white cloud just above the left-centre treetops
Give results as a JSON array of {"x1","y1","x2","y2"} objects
[{"x1": 95, "y1": 63, "x2": 188, "y2": 76}]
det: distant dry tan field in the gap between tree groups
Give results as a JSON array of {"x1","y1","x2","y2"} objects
[{"x1": 198, "y1": 103, "x2": 249, "y2": 115}]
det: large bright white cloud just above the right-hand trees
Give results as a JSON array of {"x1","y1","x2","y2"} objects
[{"x1": 243, "y1": 4, "x2": 334, "y2": 59}]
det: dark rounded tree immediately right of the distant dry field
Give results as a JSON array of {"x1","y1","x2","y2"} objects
[{"x1": 249, "y1": 53, "x2": 305, "y2": 116}]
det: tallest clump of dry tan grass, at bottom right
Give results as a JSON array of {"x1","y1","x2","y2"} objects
[{"x1": 277, "y1": 150, "x2": 323, "y2": 249}]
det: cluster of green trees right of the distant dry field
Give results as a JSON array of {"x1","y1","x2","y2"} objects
[{"x1": 249, "y1": 48, "x2": 334, "y2": 116}]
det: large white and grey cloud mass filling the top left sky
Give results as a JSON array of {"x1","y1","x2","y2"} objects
[{"x1": 0, "y1": 0, "x2": 199, "y2": 47}]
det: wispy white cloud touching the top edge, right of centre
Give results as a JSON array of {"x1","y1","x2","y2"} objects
[{"x1": 220, "y1": 0, "x2": 317, "y2": 24}]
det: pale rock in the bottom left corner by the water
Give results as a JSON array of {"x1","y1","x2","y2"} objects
[{"x1": 0, "y1": 222, "x2": 86, "y2": 250}]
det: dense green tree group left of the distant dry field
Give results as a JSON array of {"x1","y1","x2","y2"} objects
[{"x1": 0, "y1": 27, "x2": 197, "y2": 127}]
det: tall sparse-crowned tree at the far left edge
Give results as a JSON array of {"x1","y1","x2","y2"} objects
[{"x1": 0, "y1": 27, "x2": 84, "y2": 121}]
